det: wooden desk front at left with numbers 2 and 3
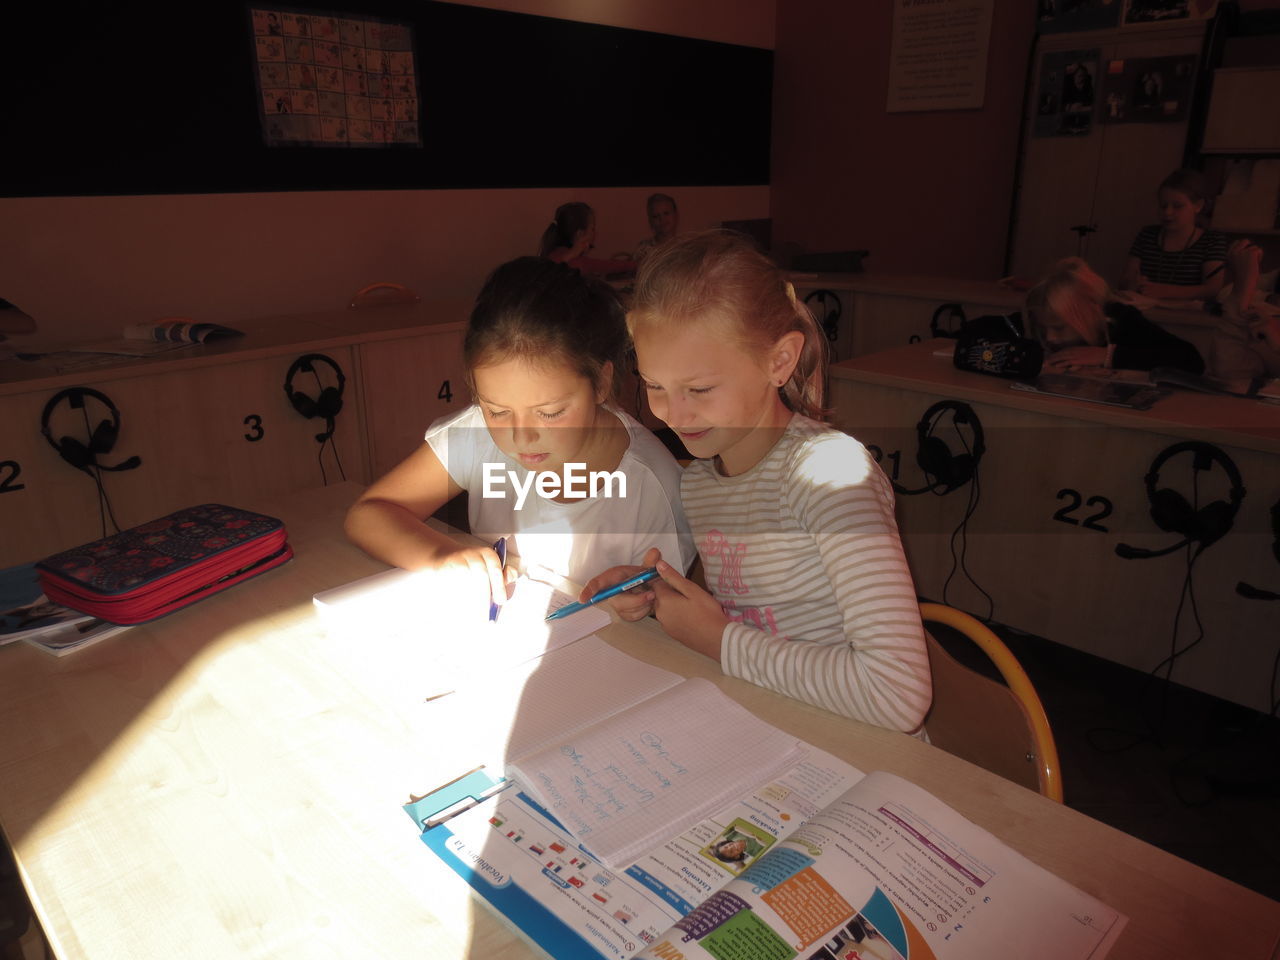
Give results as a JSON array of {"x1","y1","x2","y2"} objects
[{"x1": 0, "y1": 348, "x2": 366, "y2": 566}]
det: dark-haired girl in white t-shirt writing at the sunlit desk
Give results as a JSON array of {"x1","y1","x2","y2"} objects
[{"x1": 346, "y1": 257, "x2": 694, "y2": 603}]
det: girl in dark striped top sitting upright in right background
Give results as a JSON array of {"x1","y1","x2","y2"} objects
[{"x1": 1120, "y1": 170, "x2": 1226, "y2": 300}]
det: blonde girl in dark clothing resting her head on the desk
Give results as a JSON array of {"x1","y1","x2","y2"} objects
[{"x1": 1027, "y1": 257, "x2": 1204, "y2": 374}]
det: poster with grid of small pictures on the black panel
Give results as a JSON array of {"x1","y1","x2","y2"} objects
[{"x1": 250, "y1": 8, "x2": 422, "y2": 147}]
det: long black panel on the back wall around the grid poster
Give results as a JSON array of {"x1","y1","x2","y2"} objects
[{"x1": 0, "y1": 0, "x2": 773, "y2": 196}]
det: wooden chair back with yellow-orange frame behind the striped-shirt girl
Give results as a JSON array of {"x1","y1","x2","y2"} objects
[{"x1": 920, "y1": 603, "x2": 1062, "y2": 803}]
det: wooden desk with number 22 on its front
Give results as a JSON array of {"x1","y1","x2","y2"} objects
[{"x1": 831, "y1": 340, "x2": 1280, "y2": 712}]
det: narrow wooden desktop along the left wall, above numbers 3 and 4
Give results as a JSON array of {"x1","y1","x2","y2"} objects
[{"x1": 0, "y1": 300, "x2": 472, "y2": 397}]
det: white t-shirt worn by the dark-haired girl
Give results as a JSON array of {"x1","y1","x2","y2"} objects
[{"x1": 426, "y1": 404, "x2": 695, "y2": 584}]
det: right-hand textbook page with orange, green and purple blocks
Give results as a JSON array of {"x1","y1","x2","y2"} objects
[{"x1": 640, "y1": 773, "x2": 1126, "y2": 960}]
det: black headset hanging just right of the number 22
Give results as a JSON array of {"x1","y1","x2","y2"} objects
[{"x1": 1116, "y1": 440, "x2": 1244, "y2": 559}]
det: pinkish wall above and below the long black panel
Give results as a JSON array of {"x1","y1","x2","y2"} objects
[{"x1": 0, "y1": 0, "x2": 774, "y2": 343}]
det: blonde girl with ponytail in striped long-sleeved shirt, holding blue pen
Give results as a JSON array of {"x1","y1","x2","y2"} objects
[{"x1": 582, "y1": 230, "x2": 932, "y2": 731}]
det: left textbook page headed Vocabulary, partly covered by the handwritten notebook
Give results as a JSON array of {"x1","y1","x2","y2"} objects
[{"x1": 404, "y1": 750, "x2": 861, "y2": 960}]
